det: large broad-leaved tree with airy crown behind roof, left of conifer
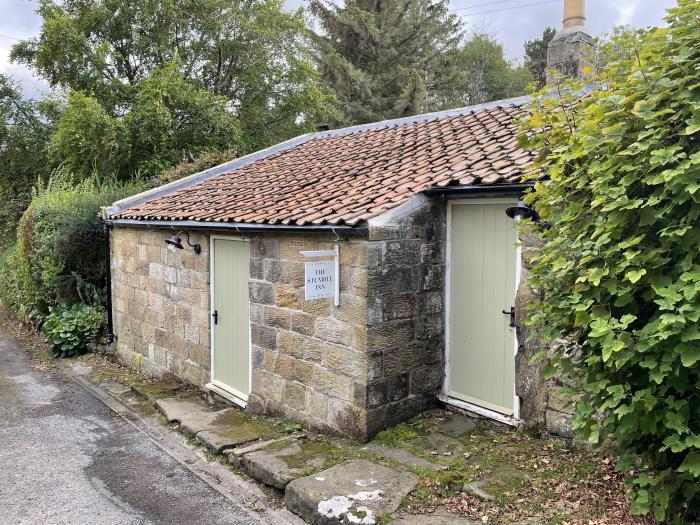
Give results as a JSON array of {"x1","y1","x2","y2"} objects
[{"x1": 12, "y1": 0, "x2": 329, "y2": 150}]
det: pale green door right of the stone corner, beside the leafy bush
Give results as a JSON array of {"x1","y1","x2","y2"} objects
[{"x1": 446, "y1": 201, "x2": 519, "y2": 416}]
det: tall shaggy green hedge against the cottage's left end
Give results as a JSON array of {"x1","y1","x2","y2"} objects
[{"x1": 0, "y1": 173, "x2": 143, "y2": 324}]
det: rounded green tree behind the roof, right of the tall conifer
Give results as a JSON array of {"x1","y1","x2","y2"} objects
[{"x1": 444, "y1": 33, "x2": 532, "y2": 107}]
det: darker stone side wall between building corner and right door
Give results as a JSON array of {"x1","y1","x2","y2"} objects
[{"x1": 364, "y1": 198, "x2": 446, "y2": 429}]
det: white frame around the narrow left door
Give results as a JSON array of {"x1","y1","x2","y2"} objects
[{"x1": 206, "y1": 235, "x2": 253, "y2": 408}]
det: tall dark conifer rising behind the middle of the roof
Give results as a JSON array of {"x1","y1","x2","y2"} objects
[{"x1": 310, "y1": 0, "x2": 462, "y2": 124}]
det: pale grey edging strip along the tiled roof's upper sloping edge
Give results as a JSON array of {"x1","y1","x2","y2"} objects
[{"x1": 106, "y1": 96, "x2": 532, "y2": 218}]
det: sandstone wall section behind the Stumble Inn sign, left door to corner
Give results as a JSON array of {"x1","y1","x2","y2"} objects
[{"x1": 248, "y1": 234, "x2": 379, "y2": 439}]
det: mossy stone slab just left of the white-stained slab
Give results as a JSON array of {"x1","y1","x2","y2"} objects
[{"x1": 240, "y1": 440, "x2": 326, "y2": 490}]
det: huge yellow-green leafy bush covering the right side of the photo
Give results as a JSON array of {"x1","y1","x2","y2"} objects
[{"x1": 522, "y1": 0, "x2": 700, "y2": 522}]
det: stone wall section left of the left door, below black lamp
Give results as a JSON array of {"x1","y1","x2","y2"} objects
[{"x1": 111, "y1": 228, "x2": 210, "y2": 385}]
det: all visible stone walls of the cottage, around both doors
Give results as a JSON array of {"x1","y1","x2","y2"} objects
[{"x1": 111, "y1": 207, "x2": 570, "y2": 439}]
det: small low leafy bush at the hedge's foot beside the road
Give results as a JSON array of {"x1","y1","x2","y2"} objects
[{"x1": 42, "y1": 303, "x2": 105, "y2": 357}]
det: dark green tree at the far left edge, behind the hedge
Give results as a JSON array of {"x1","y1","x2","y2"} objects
[{"x1": 0, "y1": 74, "x2": 56, "y2": 246}]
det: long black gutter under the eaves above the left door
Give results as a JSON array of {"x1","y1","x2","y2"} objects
[{"x1": 107, "y1": 219, "x2": 369, "y2": 236}]
